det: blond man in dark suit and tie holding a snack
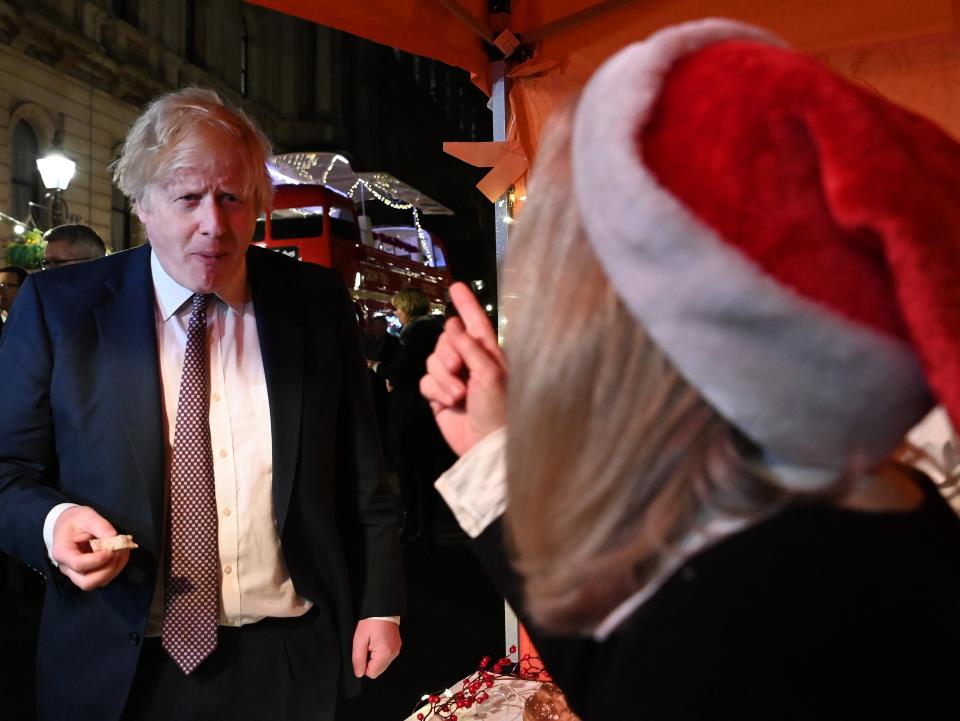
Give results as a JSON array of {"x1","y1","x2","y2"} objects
[{"x1": 0, "y1": 88, "x2": 403, "y2": 721}]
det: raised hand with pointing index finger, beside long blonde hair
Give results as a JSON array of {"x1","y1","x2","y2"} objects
[{"x1": 420, "y1": 283, "x2": 507, "y2": 455}]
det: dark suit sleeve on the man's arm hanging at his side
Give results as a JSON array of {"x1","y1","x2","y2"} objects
[{"x1": 338, "y1": 278, "x2": 405, "y2": 618}]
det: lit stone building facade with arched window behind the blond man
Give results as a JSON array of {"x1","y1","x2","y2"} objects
[{"x1": 0, "y1": 0, "x2": 360, "y2": 249}]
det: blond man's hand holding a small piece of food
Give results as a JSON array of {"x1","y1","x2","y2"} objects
[{"x1": 53, "y1": 506, "x2": 130, "y2": 591}]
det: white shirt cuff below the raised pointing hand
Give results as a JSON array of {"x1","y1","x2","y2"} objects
[{"x1": 434, "y1": 427, "x2": 507, "y2": 538}]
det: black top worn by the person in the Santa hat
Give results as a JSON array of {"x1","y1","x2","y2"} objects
[{"x1": 476, "y1": 472, "x2": 960, "y2": 721}]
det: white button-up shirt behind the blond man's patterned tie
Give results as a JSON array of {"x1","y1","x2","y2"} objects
[{"x1": 147, "y1": 249, "x2": 311, "y2": 635}]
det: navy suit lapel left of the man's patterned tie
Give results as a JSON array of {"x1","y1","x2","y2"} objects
[{"x1": 94, "y1": 246, "x2": 164, "y2": 547}]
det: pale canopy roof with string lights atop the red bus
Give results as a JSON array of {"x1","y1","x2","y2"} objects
[{"x1": 270, "y1": 153, "x2": 453, "y2": 215}]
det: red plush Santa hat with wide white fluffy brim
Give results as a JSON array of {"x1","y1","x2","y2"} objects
[{"x1": 572, "y1": 20, "x2": 960, "y2": 469}]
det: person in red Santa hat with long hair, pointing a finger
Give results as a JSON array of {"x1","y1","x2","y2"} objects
[{"x1": 421, "y1": 20, "x2": 960, "y2": 721}]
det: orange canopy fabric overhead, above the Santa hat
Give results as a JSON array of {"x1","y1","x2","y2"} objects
[{"x1": 249, "y1": 0, "x2": 960, "y2": 198}]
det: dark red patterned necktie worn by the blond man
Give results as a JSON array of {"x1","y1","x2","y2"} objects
[{"x1": 163, "y1": 295, "x2": 219, "y2": 674}]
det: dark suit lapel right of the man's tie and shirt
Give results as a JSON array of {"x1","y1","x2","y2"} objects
[{"x1": 247, "y1": 248, "x2": 305, "y2": 535}]
